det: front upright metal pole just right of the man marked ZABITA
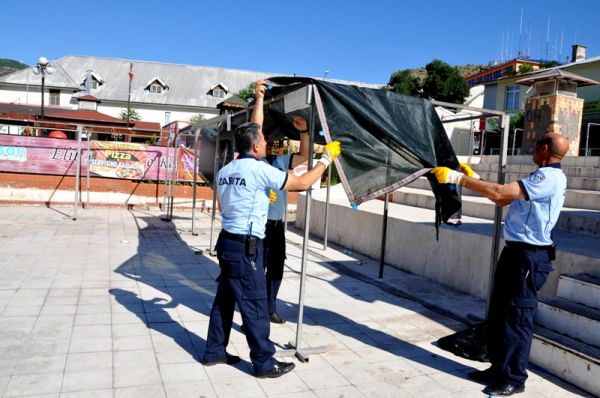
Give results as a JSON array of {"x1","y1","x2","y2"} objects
[{"x1": 294, "y1": 85, "x2": 316, "y2": 362}]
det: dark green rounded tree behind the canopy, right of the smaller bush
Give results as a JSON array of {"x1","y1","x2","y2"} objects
[{"x1": 422, "y1": 59, "x2": 469, "y2": 104}]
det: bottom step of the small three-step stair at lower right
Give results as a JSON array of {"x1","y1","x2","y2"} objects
[{"x1": 530, "y1": 325, "x2": 600, "y2": 396}]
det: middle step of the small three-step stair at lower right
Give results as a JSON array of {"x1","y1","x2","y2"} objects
[{"x1": 535, "y1": 297, "x2": 600, "y2": 348}]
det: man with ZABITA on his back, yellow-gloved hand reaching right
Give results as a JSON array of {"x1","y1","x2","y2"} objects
[{"x1": 203, "y1": 81, "x2": 340, "y2": 378}]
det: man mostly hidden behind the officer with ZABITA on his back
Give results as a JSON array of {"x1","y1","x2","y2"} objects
[{"x1": 251, "y1": 105, "x2": 309, "y2": 323}]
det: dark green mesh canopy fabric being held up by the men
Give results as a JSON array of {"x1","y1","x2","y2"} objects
[{"x1": 263, "y1": 77, "x2": 460, "y2": 222}]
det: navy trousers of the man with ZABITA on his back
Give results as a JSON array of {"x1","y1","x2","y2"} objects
[{"x1": 204, "y1": 233, "x2": 275, "y2": 373}]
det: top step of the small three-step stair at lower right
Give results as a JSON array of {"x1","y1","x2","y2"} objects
[{"x1": 557, "y1": 270, "x2": 600, "y2": 309}]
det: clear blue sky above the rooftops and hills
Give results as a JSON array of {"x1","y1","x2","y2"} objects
[{"x1": 0, "y1": 0, "x2": 600, "y2": 83}]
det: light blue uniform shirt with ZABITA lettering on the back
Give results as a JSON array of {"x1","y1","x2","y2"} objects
[{"x1": 217, "y1": 155, "x2": 287, "y2": 239}]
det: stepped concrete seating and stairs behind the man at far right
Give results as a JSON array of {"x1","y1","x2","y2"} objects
[{"x1": 392, "y1": 156, "x2": 600, "y2": 396}]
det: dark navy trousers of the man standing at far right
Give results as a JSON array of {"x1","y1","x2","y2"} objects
[{"x1": 487, "y1": 247, "x2": 552, "y2": 386}]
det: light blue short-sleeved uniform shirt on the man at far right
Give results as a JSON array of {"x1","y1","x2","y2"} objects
[{"x1": 504, "y1": 163, "x2": 567, "y2": 246}]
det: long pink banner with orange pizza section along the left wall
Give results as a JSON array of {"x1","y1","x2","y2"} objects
[{"x1": 0, "y1": 134, "x2": 206, "y2": 182}]
